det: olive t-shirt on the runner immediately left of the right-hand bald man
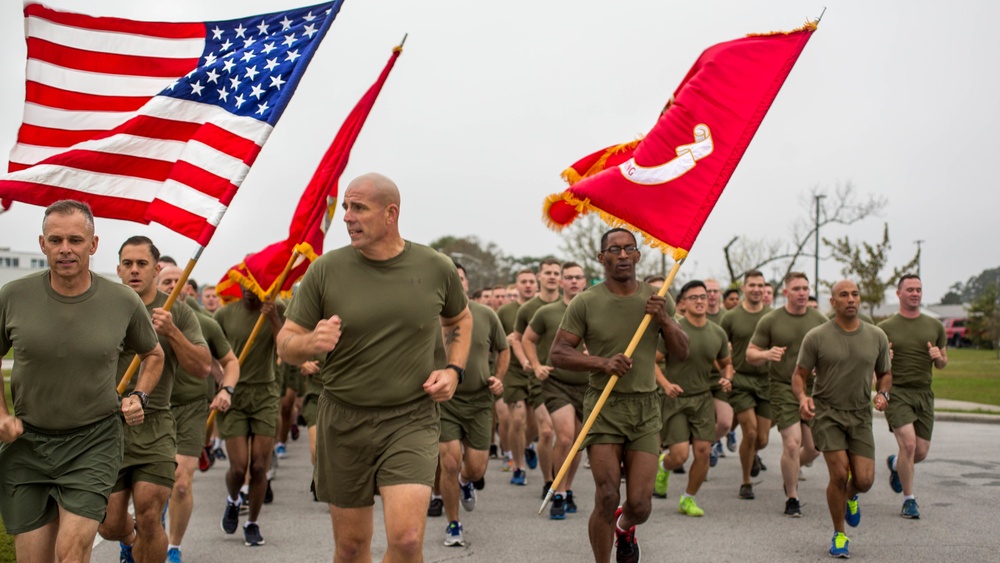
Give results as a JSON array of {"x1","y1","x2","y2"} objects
[{"x1": 750, "y1": 307, "x2": 829, "y2": 385}]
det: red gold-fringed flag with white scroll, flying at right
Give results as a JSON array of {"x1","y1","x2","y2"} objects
[{"x1": 544, "y1": 23, "x2": 816, "y2": 260}]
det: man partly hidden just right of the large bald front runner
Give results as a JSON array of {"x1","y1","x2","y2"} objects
[{"x1": 438, "y1": 263, "x2": 510, "y2": 546}]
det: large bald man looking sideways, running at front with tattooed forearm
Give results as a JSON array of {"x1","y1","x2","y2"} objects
[{"x1": 278, "y1": 174, "x2": 472, "y2": 562}]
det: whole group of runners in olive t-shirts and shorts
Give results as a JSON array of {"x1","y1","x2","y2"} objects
[{"x1": 0, "y1": 174, "x2": 947, "y2": 563}]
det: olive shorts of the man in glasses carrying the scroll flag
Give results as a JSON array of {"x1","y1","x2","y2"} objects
[{"x1": 583, "y1": 385, "x2": 663, "y2": 455}]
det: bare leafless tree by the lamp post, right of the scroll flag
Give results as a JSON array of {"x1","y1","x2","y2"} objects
[{"x1": 722, "y1": 182, "x2": 888, "y2": 284}]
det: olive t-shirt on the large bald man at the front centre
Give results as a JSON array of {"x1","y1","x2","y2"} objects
[{"x1": 287, "y1": 241, "x2": 468, "y2": 407}]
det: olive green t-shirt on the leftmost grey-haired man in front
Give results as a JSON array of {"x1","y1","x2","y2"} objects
[{"x1": 0, "y1": 270, "x2": 157, "y2": 431}]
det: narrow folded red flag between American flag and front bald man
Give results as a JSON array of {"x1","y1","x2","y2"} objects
[{"x1": 215, "y1": 46, "x2": 403, "y2": 302}]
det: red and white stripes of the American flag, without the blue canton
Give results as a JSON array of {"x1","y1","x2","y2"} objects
[{"x1": 0, "y1": 4, "x2": 272, "y2": 245}]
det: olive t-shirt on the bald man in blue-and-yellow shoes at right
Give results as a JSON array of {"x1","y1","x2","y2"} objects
[{"x1": 796, "y1": 321, "x2": 890, "y2": 410}]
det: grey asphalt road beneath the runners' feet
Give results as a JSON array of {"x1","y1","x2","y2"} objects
[{"x1": 93, "y1": 418, "x2": 1000, "y2": 563}]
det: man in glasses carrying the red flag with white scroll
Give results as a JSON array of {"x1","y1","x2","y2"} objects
[{"x1": 549, "y1": 229, "x2": 688, "y2": 561}]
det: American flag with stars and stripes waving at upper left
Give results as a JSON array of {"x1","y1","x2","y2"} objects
[{"x1": 0, "y1": 0, "x2": 343, "y2": 245}]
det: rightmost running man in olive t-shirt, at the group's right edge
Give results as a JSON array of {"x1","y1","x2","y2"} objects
[{"x1": 878, "y1": 274, "x2": 948, "y2": 519}]
